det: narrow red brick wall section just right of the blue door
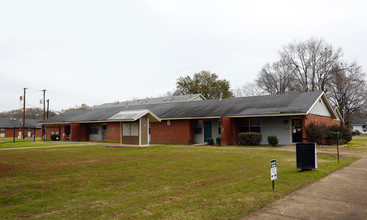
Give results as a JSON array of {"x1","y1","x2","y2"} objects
[{"x1": 221, "y1": 116, "x2": 238, "y2": 145}]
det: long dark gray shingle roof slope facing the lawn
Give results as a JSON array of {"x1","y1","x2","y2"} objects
[{"x1": 41, "y1": 91, "x2": 322, "y2": 123}]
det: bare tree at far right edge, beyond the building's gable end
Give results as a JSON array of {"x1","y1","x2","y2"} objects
[{"x1": 327, "y1": 62, "x2": 367, "y2": 125}]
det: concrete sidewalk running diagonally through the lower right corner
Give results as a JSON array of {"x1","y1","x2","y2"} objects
[{"x1": 242, "y1": 157, "x2": 367, "y2": 219}]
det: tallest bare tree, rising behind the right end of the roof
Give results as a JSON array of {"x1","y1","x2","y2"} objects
[{"x1": 256, "y1": 38, "x2": 343, "y2": 94}]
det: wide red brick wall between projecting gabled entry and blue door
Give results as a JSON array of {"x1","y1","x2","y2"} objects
[{"x1": 150, "y1": 119, "x2": 194, "y2": 144}]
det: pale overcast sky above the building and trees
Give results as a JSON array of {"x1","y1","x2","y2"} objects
[{"x1": 0, "y1": 0, "x2": 367, "y2": 111}]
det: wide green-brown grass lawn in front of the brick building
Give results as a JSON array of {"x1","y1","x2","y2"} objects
[{"x1": 0, "y1": 145, "x2": 355, "y2": 219}]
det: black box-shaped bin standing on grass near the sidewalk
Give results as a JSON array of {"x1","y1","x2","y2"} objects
[{"x1": 296, "y1": 143, "x2": 317, "y2": 170}]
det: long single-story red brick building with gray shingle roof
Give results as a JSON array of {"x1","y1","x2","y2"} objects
[{"x1": 42, "y1": 91, "x2": 342, "y2": 146}]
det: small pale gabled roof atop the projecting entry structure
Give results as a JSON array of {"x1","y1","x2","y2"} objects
[{"x1": 107, "y1": 109, "x2": 161, "y2": 122}]
